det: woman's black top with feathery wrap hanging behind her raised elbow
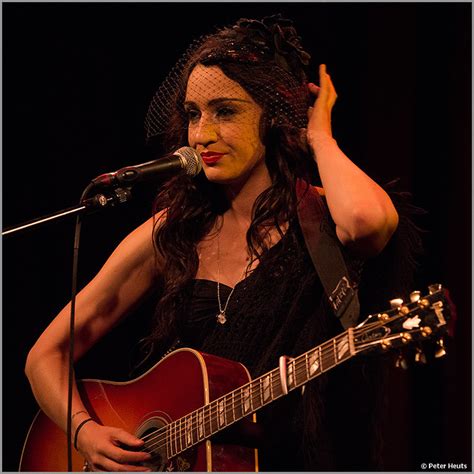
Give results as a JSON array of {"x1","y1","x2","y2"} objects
[{"x1": 171, "y1": 189, "x2": 421, "y2": 471}]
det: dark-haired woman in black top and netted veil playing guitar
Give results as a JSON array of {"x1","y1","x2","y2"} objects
[{"x1": 26, "y1": 17, "x2": 404, "y2": 471}]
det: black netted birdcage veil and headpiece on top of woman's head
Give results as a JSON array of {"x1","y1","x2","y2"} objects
[{"x1": 145, "y1": 15, "x2": 310, "y2": 148}]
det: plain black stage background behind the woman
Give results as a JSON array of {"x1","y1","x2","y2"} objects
[{"x1": 2, "y1": 3, "x2": 471, "y2": 471}]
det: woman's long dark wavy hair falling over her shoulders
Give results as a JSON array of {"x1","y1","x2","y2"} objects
[{"x1": 141, "y1": 16, "x2": 318, "y2": 356}]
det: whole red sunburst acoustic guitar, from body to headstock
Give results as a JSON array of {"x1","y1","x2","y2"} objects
[{"x1": 20, "y1": 285, "x2": 451, "y2": 472}]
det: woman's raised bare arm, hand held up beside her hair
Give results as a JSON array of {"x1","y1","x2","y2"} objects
[{"x1": 307, "y1": 64, "x2": 398, "y2": 257}]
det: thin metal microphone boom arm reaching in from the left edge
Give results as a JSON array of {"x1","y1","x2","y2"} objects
[{"x1": 2, "y1": 188, "x2": 132, "y2": 237}]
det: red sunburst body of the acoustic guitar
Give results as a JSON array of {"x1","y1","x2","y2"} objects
[{"x1": 20, "y1": 348, "x2": 258, "y2": 472}]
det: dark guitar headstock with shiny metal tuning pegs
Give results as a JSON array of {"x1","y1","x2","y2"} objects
[{"x1": 353, "y1": 284, "x2": 452, "y2": 366}]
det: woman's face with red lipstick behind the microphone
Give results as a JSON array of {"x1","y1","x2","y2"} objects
[{"x1": 184, "y1": 65, "x2": 265, "y2": 184}]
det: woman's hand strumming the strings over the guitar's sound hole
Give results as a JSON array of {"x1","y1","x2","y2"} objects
[{"x1": 77, "y1": 421, "x2": 151, "y2": 472}]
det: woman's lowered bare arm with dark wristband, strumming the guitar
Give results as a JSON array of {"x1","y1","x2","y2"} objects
[{"x1": 25, "y1": 219, "x2": 158, "y2": 471}]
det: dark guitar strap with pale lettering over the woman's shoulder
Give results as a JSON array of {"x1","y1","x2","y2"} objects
[{"x1": 296, "y1": 179, "x2": 360, "y2": 329}]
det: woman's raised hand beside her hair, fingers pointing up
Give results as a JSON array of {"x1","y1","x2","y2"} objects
[{"x1": 307, "y1": 64, "x2": 337, "y2": 145}]
